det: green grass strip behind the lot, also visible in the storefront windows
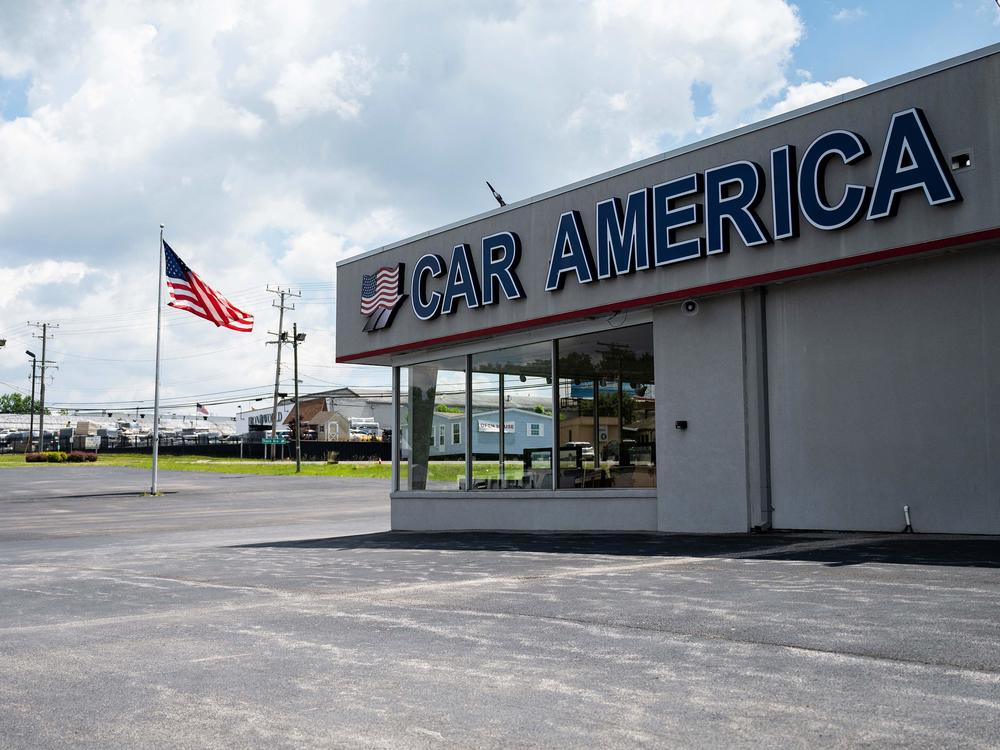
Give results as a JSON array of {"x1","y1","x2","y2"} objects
[{"x1": 0, "y1": 453, "x2": 522, "y2": 482}]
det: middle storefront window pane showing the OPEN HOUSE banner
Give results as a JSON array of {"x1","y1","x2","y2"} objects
[{"x1": 472, "y1": 341, "x2": 553, "y2": 490}]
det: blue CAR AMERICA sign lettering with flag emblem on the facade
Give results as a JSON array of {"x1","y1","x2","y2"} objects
[{"x1": 362, "y1": 107, "x2": 962, "y2": 331}]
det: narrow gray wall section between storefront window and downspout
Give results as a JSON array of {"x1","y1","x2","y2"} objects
[{"x1": 653, "y1": 293, "x2": 749, "y2": 532}]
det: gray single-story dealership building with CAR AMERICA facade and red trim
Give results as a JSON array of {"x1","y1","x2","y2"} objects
[{"x1": 337, "y1": 45, "x2": 1000, "y2": 534}]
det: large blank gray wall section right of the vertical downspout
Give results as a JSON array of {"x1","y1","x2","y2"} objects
[{"x1": 764, "y1": 247, "x2": 1000, "y2": 534}]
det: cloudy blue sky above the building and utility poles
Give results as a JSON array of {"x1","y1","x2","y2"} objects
[{"x1": 0, "y1": 0, "x2": 1000, "y2": 414}]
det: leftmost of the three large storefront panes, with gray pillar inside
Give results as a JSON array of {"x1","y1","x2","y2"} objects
[{"x1": 400, "y1": 357, "x2": 465, "y2": 490}]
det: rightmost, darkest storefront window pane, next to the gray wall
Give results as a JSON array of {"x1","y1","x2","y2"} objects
[{"x1": 558, "y1": 324, "x2": 656, "y2": 488}]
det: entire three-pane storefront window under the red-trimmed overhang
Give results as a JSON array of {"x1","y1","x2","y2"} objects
[{"x1": 397, "y1": 324, "x2": 656, "y2": 491}]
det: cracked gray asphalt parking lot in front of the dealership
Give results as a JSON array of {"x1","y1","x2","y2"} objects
[{"x1": 0, "y1": 466, "x2": 1000, "y2": 748}]
